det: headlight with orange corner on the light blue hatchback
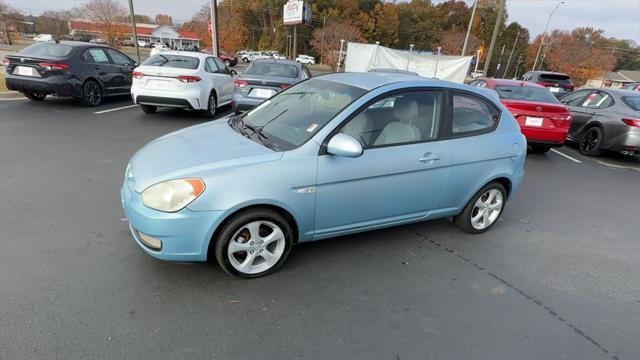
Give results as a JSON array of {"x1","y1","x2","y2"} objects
[{"x1": 142, "y1": 179, "x2": 205, "y2": 212}]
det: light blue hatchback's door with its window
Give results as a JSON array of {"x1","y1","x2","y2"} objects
[{"x1": 315, "y1": 90, "x2": 449, "y2": 238}]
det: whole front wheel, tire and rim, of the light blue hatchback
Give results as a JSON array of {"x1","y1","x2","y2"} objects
[{"x1": 213, "y1": 208, "x2": 293, "y2": 278}]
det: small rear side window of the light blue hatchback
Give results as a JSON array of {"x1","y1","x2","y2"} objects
[{"x1": 451, "y1": 94, "x2": 499, "y2": 136}]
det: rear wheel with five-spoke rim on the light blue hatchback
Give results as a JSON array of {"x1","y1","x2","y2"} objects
[{"x1": 454, "y1": 182, "x2": 507, "y2": 234}]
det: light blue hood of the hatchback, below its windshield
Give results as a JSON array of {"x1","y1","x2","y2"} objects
[{"x1": 127, "y1": 120, "x2": 282, "y2": 192}]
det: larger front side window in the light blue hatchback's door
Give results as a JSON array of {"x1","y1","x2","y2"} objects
[{"x1": 340, "y1": 91, "x2": 443, "y2": 149}]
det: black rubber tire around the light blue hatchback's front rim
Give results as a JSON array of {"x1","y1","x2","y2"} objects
[{"x1": 212, "y1": 208, "x2": 294, "y2": 278}]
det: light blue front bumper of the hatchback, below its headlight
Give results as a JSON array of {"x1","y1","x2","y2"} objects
[{"x1": 120, "y1": 182, "x2": 223, "y2": 261}]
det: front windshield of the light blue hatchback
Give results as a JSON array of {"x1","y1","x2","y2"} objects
[{"x1": 229, "y1": 79, "x2": 366, "y2": 151}]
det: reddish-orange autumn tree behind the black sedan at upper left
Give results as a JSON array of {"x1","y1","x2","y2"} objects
[{"x1": 80, "y1": 0, "x2": 129, "y2": 46}]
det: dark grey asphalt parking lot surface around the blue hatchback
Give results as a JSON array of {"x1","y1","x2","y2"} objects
[{"x1": 0, "y1": 97, "x2": 640, "y2": 360}]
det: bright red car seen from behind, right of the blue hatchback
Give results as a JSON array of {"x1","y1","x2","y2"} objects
[{"x1": 470, "y1": 78, "x2": 571, "y2": 154}]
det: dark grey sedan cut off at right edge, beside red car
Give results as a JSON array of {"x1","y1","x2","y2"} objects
[{"x1": 560, "y1": 89, "x2": 640, "y2": 156}]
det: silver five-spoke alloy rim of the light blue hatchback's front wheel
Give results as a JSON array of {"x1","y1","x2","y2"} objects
[{"x1": 227, "y1": 220, "x2": 285, "y2": 274}]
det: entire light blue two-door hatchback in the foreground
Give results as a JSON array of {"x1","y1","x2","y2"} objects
[{"x1": 122, "y1": 72, "x2": 526, "y2": 277}]
